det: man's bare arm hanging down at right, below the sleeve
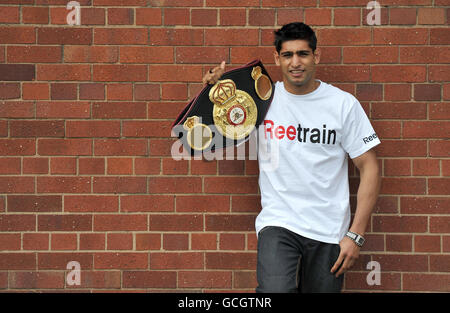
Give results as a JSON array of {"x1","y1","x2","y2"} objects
[{"x1": 331, "y1": 149, "x2": 381, "y2": 277}]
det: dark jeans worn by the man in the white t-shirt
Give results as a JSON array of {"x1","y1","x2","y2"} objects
[{"x1": 256, "y1": 226, "x2": 343, "y2": 293}]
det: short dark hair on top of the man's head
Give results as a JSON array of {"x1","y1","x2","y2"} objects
[{"x1": 274, "y1": 22, "x2": 317, "y2": 53}]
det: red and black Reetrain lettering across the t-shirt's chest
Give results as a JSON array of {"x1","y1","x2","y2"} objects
[{"x1": 264, "y1": 120, "x2": 336, "y2": 145}]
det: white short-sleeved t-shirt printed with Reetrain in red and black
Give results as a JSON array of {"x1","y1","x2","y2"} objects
[{"x1": 255, "y1": 80, "x2": 380, "y2": 243}]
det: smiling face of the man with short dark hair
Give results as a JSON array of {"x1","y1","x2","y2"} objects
[{"x1": 274, "y1": 39, "x2": 320, "y2": 93}]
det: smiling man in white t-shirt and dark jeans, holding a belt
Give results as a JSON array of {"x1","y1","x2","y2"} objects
[{"x1": 203, "y1": 23, "x2": 381, "y2": 292}]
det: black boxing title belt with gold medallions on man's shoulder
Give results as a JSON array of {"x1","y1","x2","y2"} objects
[{"x1": 172, "y1": 60, "x2": 273, "y2": 155}]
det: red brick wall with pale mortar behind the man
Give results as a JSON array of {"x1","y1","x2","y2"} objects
[{"x1": 0, "y1": 0, "x2": 450, "y2": 292}]
